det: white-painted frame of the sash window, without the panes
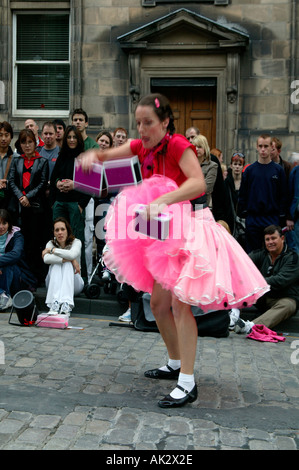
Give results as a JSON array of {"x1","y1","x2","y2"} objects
[{"x1": 12, "y1": 9, "x2": 72, "y2": 118}]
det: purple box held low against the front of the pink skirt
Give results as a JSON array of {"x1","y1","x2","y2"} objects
[{"x1": 134, "y1": 204, "x2": 172, "y2": 241}]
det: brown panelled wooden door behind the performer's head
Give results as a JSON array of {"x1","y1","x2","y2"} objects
[{"x1": 152, "y1": 86, "x2": 217, "y2": 148}]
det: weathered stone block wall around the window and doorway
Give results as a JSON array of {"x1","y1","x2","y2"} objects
[{"x1": 0, "y1": 0, "x2": 299, "y2": 161}]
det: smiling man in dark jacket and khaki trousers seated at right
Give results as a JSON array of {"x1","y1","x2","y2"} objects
[{"x1": 235, "y1": 225, "x2": 299, "y2": 334}]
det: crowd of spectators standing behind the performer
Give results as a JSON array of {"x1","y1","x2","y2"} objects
[{"x1": 0, "y1": 115, "x2": 299, "y2": 321}]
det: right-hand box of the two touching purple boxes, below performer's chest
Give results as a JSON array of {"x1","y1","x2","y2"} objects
[{"x1": 104, "y1": 156, "x2": 142, "y2": 193}]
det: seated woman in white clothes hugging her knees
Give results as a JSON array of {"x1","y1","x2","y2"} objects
[{"x1": 43, "y1": 217, "x2": 84, "y2": 315}]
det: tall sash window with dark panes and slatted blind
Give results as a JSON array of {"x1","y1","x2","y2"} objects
[{"x1": 13, "y1": 12, "x2": 70, "y2": 117}]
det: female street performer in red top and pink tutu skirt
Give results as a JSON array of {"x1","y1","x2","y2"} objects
[{"x1": 78, "y1": 94, "x2": 269, "y2": 408}]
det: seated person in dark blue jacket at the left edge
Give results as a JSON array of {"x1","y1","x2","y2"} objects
[{"x1": 0, "y1": 209, "x2": 37, "y2": 310}]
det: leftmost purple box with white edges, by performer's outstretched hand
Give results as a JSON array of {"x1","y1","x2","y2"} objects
[{"x1": 73, "y1": 162, "x2": 107, "y2": 197}]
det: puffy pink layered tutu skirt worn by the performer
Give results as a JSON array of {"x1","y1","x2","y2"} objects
[{"x1": 105, "y1": 175, "x2": 269, "y2": 312}]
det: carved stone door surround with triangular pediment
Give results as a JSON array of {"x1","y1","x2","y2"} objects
[{"x1": 118, "y1": 8, "x2": 249, "y2": 158}]
